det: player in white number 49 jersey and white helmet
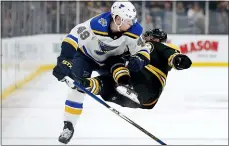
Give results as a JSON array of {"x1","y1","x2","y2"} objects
[{"x1": 53, "y1": 1, "x2": 150, "y2": 144}]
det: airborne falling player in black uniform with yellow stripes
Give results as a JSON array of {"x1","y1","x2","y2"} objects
[{"x1": 70, "y1": 29, "x2": 192, "y2": 109}]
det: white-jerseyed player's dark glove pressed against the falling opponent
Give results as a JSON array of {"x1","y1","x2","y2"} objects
[{"x1": 126, "y1": 55, "x2": 145, "y2": 72}]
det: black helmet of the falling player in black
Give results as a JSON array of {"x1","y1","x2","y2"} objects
[{"x1": 143, "y1": 28, "x2": 167, "y2": 42}]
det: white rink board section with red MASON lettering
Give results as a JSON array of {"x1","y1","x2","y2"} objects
[{"x1": 168, "y1": 35, "x2": 228, "y2": 63}]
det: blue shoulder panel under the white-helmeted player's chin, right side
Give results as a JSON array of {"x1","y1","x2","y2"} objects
[{"x1": 124, "y1": 22, "x2": 143, "y2": 39}]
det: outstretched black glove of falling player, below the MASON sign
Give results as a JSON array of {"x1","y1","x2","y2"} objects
[{"x1": 172, "y1": 54, "x2": 192, "y2": 70}]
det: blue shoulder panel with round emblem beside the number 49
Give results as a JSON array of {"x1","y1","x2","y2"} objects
[{"x1": 90, "y1": 12, "x2": 111, "y2": 36}]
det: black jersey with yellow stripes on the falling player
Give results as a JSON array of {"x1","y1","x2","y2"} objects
[{"x1": 127, "y1": 42, "x2": 180, "y2": 109}]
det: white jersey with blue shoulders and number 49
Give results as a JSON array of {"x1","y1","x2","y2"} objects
[{"x1": 64, "y1": 12, "x2": 150, "y2": 65}]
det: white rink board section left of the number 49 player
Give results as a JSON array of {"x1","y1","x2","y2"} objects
[{"x1": 2, "y1": 35, "x2": 64, "y2": 89}]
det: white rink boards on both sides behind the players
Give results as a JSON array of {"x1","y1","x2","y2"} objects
[{"x1": 2, "y1": 34, "x2": 228, "y2": 89}]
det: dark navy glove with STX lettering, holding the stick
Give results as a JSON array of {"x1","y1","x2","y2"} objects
[{"x1": 52, "y1": 57, "x2": 72, "y2": 81}]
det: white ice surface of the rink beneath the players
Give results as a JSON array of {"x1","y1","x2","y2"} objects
[{"x1": 2, "y1": 68, "x2": 228, "y2": 145}]
